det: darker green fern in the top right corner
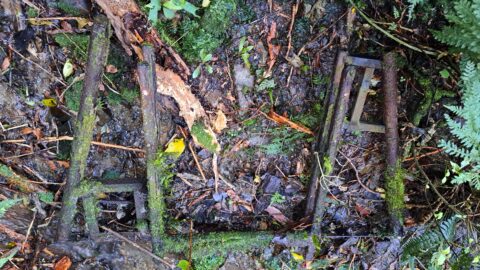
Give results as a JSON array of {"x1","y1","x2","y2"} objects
[{"x1": 434, "y1": 0, "x2": 480, "y2": 57}]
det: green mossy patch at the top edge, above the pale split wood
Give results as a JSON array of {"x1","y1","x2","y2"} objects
[{"x1": 155, "y1": 0, "x2": 236, "y2": 62}]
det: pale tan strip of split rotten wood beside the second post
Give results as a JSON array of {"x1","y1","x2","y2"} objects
[{"x1": 156, "y1": 65, "x2": 220, "y2": 152}]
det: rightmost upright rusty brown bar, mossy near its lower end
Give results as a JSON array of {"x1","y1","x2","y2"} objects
[{"x1": 383, "y1": 52, "x2": 405, "y2": 234}]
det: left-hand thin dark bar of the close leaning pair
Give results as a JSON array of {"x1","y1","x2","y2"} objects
[{"x1": 305, "y1": 51, "x2": 347, "y2": 216}]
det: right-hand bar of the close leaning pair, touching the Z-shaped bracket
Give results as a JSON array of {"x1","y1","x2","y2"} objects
[{"x1": 311, "y1": 66, "x2": 356, "y2": 234}]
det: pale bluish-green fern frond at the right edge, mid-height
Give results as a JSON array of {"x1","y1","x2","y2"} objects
[{"x1": 439, "y1": 60, "x2": 480, "y2": 189}]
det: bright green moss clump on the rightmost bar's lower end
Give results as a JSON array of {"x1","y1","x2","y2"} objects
[{"x1": 385, "y1": 165, "x2": 405, "y2": 224}]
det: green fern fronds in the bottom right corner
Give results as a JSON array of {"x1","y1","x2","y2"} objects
[{"x1": 402, "y1": 216, "x2": 480, "y2": 270}]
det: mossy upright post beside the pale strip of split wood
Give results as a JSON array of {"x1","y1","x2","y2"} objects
[{"x1": 137, "y1": 45, "x2": 165, "y2": 254}]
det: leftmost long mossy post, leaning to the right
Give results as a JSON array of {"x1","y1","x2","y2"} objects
[{"x1": 57, "y1": 15, "x2": 111, "y2": 241}]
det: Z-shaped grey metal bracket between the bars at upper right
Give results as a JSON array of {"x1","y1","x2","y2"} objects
[{"x1": 345, "y1": 56, "x2": 385, "y2": 133}]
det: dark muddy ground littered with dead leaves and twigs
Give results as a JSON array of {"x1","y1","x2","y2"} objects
[{"x1": 0, "y1": 0, "x2": 478, "y2": 269}]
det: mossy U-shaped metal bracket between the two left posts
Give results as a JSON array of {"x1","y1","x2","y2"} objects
[{"x1": 80, "y1": 178, "x2": 147, "y2": 238}]
